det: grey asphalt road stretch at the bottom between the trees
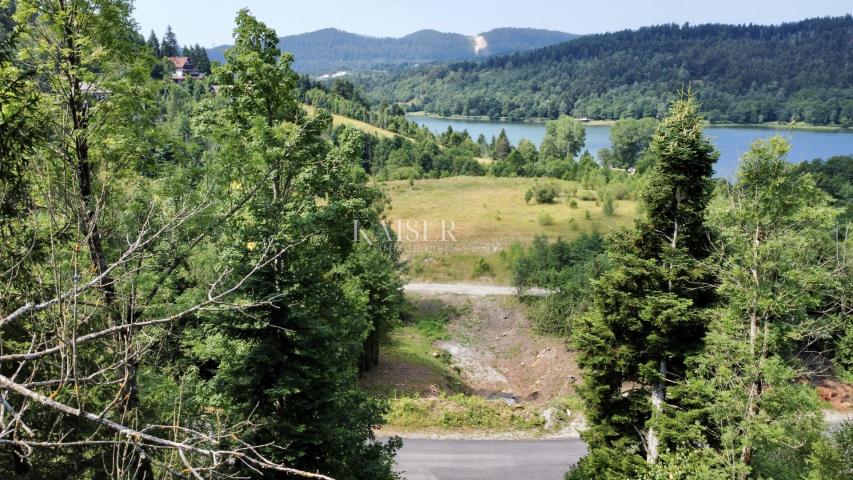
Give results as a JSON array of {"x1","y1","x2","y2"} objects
[{"x1": 397, "y1": 438, "x2": 586, "y2": 480}]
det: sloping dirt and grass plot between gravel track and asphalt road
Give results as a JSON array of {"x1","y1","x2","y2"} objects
[{"x1": 363, "y1": 294, "x2": 580, "y2": 438}]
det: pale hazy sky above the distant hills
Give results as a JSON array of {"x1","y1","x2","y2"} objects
[{"x1": 134, "y1": 0, "x2": 853, "y2": 47}]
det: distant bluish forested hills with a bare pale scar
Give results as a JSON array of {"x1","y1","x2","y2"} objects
[{"x1": 208, "y1": 28, "x2": 575, "y2": 73}]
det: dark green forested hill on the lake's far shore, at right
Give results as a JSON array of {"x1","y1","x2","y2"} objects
[{"x1": 365, "y1": 15, "x2": 853, "y2": 125}]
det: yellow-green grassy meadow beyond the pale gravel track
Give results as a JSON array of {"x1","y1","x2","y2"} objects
[{"x1": 382, "y1": 177, "x2": 637, "y2": 283}]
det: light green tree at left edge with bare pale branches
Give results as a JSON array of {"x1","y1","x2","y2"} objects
[{"x1": 0, "y1": 0, "x2": 344, "y2": 479}]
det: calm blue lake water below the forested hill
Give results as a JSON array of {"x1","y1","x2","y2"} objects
[{"x1": 408, "y1": 116, "x2": 853, "y2": 178}]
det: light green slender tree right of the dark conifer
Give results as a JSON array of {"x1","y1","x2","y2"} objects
[{"x1": 681, "y1": 136, "x2": 850, "y2": 479}]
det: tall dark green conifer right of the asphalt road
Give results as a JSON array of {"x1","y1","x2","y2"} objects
[{"x1": 574, "y1": 97, "x2": 717, "y2": 478}]
